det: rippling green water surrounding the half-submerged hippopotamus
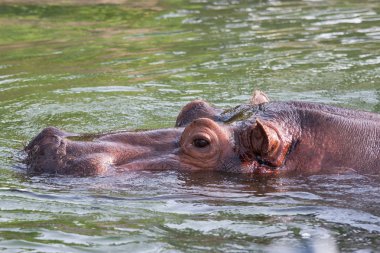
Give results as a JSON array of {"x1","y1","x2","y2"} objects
[{"x1": 0, "y1": 0, "x2": 380, "y2": 252}]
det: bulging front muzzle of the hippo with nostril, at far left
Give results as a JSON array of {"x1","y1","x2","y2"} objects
[{"x1": 25, "y1": 127, "x2": 133, "y2": 176}]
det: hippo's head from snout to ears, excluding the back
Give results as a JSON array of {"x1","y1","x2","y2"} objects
[{"x1": 25, "y1": 92, "x2": 289, "y2": 175}]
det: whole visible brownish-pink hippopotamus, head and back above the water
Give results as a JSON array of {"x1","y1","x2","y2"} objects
[{"x1": 25, "y1": 91, "x2": 380, "y2": 176}]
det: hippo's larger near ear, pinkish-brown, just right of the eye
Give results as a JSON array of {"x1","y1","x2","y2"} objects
[{"x1": 251, "y1": 119, "x2": 289, "y2": 167}]
